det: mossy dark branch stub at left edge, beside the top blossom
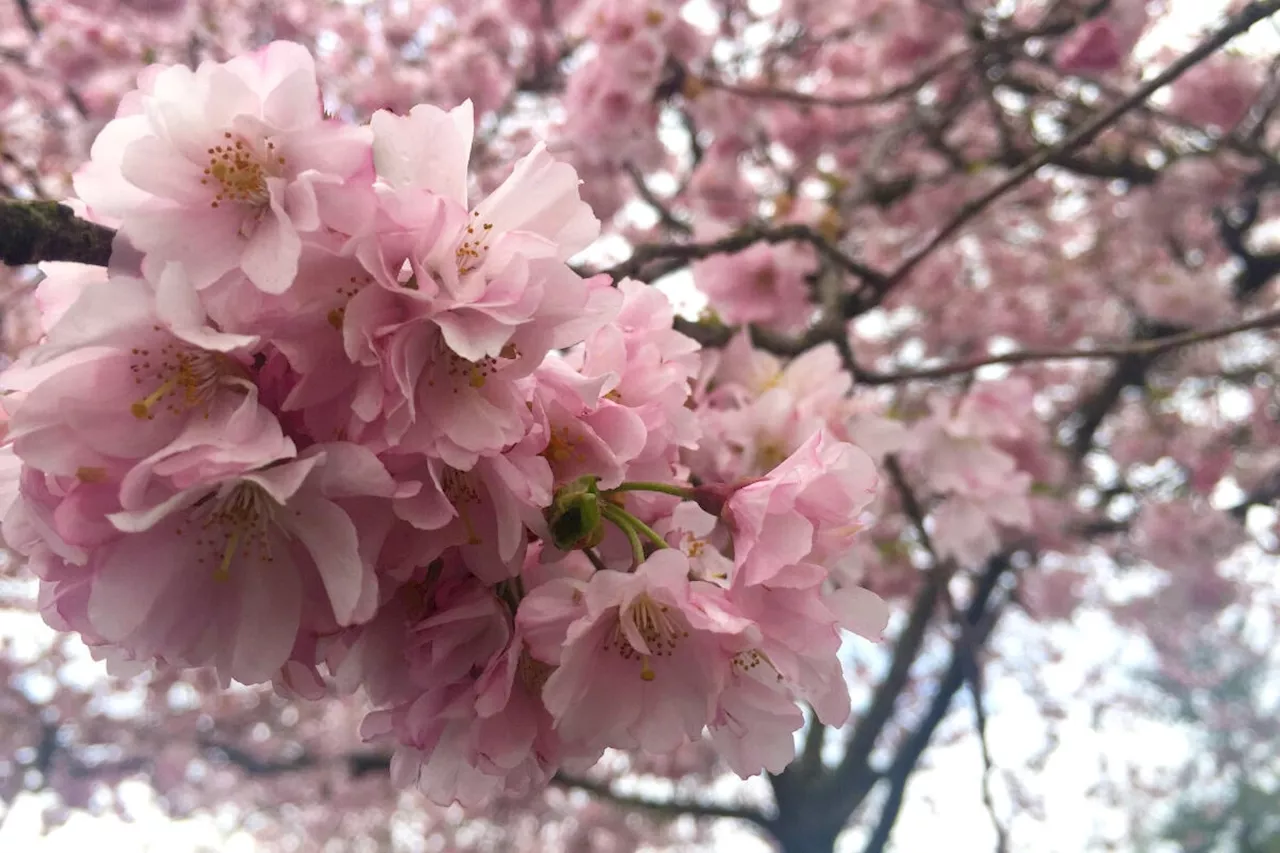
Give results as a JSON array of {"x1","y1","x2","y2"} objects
[{"x1": 0, "y1": 199, "x2": 115, "y2": 266}]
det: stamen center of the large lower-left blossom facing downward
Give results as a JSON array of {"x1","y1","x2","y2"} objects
[{"x1": 178, "y1": 482, "x2": 280, "y2": 581}]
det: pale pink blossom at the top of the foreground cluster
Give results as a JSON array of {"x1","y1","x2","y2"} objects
[{"x1": 76, "y1": 42, "x2": 372, "y2": 293}]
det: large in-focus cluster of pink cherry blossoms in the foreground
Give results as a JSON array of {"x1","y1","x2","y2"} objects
[{"x1": 3, "y1": 42, "x2": 887, "y2": 803}]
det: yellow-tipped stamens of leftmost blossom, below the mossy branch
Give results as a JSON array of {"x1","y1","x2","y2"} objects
[{"x1": 129, "y1": 343, "x2": 233, "y2": 420}]
